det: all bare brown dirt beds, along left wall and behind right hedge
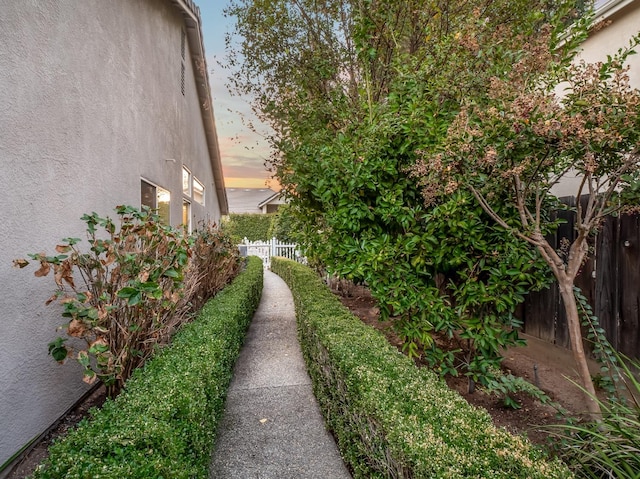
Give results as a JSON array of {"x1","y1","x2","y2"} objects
[{"x1": 6, "y1": 288, "x2": 598, "y2": 479}]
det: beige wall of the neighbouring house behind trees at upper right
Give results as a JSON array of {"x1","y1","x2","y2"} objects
[{"x1": 551, "y1": 0, "x2": 640, "y2": 197}]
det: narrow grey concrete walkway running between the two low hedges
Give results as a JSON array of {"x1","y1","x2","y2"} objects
[{"x1": 209, "y1": 271, "x2": 351, "y2": 479}]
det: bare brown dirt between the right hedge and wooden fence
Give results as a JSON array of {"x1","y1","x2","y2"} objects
[{"x1": 338, "y1": 288, "x2": 599, "y2": 446}]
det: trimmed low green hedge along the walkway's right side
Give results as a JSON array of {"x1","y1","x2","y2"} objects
[{"x1": 271, "y1": 258, "x2": 572, "y2": 479}]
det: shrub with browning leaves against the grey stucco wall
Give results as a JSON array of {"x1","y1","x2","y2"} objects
[{"x1": 16, "y1": 206, "x2": 238, "y2": 396}]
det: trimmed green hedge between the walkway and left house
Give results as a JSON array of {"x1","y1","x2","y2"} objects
[{"x1": 33, "y1": 257, "x2": 263, "y2": 479}]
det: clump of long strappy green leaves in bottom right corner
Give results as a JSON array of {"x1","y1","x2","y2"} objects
[{"x1": 550, "y1": 355, "x2": 640, "y2": 479}]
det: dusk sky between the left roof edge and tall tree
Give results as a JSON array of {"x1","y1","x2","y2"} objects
[{"x1": 197, "y1": 0, "x2": 279, "y2": 190}]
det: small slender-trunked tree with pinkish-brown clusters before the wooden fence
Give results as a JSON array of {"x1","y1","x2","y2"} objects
[{"x1": 412, "y1": 26, "x2": 640, "y2": 415}]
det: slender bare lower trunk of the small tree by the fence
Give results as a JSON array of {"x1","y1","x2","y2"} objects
[{"x1": 558, "y1": 277, "x2": 602, "y2": 420}]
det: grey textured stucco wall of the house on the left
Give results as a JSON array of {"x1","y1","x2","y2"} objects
[{"x1": 0, "y1": 0, "x2": 220, "y2": 465}]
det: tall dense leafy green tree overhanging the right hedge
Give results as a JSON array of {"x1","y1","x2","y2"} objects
[{"x1": 228, "y1": 0, "x2": 573, "y2": 394}]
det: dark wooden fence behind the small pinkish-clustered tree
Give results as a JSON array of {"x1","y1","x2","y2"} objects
[{"x1": 521, "y1": 197, "x2": 640, "y2": 358}]
